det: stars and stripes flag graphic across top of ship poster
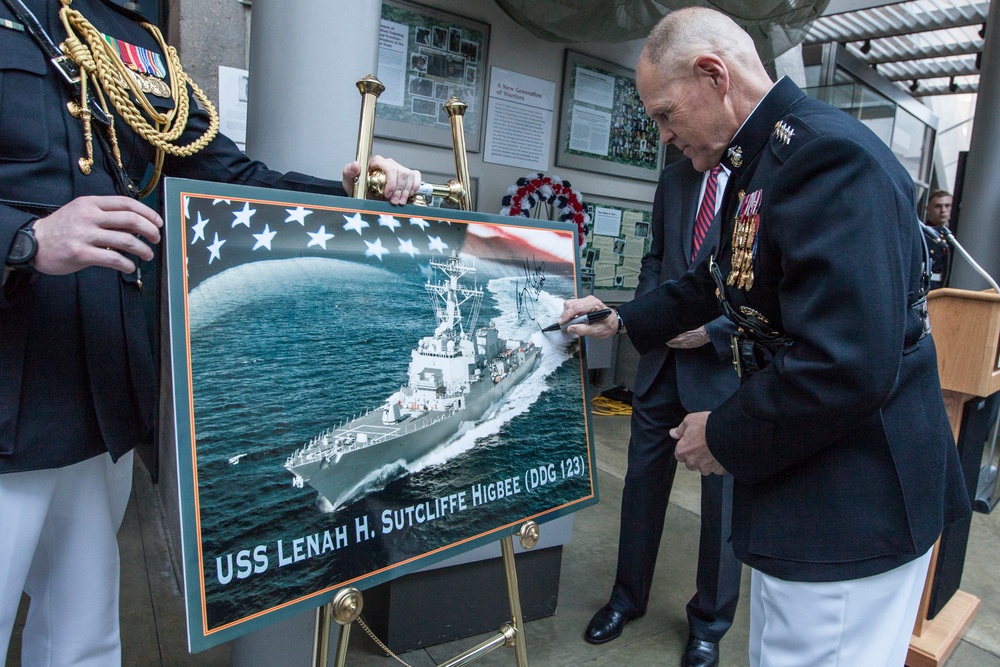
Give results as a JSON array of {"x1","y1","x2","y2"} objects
[{"x1": 182, "y1": 193, "x2": 575, "y2": 290}]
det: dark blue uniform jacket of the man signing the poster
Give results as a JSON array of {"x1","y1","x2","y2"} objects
[{"x1": 620, "y1": 79, "x2": 970, "y2": 581}]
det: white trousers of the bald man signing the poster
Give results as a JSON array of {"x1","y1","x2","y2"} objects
[{"x1": 750, "y1": 549, "x2": 933, "y2": 667}]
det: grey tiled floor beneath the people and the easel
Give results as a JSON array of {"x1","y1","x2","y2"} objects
[{"x1": 7, "y1": 417, "x2": 1000, "y2": 667}]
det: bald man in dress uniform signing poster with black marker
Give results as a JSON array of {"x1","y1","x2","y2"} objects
[{"x1": 560, "y1": 8, "x2": 970, "y2": 667}]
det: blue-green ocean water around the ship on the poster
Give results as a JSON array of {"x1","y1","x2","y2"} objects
[{"x1": 190, "y1": 258, "x2": 594, "y2": 632}]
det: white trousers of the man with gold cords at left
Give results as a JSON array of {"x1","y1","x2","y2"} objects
[{"x1": 0, "y1": 452, "x2": 132, "y2": 667}]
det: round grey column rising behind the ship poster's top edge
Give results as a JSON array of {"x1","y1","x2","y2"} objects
[{"x1": 247, "y1": 0, "x2": 382, "y2": 181}]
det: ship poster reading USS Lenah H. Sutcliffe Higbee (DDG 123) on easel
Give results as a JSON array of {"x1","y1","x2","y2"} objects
[{"x1": 165, "y1": 179, "x2": 598, "y2": 651}]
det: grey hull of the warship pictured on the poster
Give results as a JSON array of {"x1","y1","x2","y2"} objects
[{"x1": 286, "y1": 348, "x2": 538, "y2": 509}]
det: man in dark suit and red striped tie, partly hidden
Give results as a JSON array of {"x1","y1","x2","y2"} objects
[{"x1": 584, "y1": 159, "x2": 741, "y2": 667}]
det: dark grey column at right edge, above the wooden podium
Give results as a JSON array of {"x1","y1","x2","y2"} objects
[{"x1": 949, "y1": 0, "x2": 1000, "y2": 290}]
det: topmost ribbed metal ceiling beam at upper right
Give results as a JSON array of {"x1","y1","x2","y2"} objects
[{"x1": 804, "y1": 2, "x2": 990, "y2": 45}]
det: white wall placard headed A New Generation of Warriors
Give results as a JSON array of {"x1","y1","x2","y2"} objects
[{"x1": 483, "y1": 67, "x2": 556, "y2": 171}]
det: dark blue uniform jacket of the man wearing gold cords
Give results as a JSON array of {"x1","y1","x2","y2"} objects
[{"x1": 0, "y1": 0, "x2": 344, "y2": 473}]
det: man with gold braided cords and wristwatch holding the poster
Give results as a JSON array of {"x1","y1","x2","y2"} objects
[{"x1": 0, "y1": 0, "x2": 419, "y2": 667}]
